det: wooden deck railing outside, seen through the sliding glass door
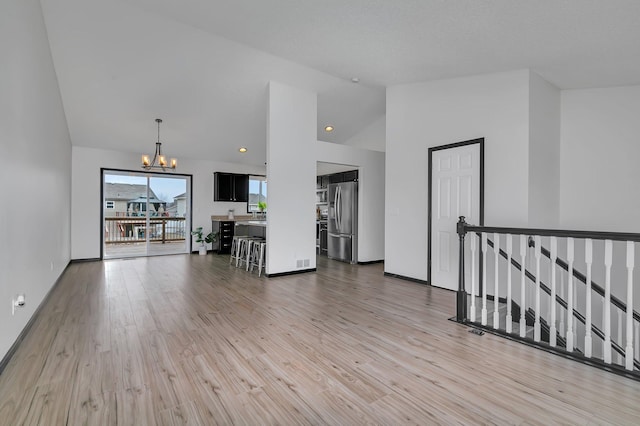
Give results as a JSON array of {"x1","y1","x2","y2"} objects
[{"x1": 104, "y1": 217, "x2": 187, "y2": 244}]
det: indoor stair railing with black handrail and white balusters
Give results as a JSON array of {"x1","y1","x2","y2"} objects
[{"x1": 456, "y1": 217, "x2": 640, "y2": 373}]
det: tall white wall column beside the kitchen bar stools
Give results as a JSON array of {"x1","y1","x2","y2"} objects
[{"x1": 266, "y1": 81, "x2": 317, "y2": 274}]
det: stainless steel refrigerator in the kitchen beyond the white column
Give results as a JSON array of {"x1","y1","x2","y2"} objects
[{"x1": 327, "y1": 182, "x2": 358, "y2": 263}]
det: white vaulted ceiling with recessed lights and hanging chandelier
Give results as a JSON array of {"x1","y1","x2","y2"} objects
[{"x1": 41, "y1": 0, "x2": 640, "y2": 164}]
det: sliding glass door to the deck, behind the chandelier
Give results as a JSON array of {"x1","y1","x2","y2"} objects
[{"x1": 102, "y1": 170, "x2": 191, "y2": 259}]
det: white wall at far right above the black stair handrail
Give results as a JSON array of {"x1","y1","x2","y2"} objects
[{"x1": 560, "y1": 86, "x2": 640, "y2": 232}]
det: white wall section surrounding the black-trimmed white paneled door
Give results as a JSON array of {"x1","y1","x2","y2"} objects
[{"x1": 385, "y1": 70, "x2": 529, "y2": 280}]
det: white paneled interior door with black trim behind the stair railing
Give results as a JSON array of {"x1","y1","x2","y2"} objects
[{"x1": 430, "y1": 143, "x2": 480, "y2": 290}]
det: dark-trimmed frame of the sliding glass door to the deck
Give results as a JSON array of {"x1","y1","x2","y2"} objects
[{"x1": 100, "y1": 167, "x2": 193, "y2": 260}]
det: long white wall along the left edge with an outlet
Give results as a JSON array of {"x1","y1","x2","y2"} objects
[{"x1": 0, "y1": 0, "x2": 71, "y2": 358}]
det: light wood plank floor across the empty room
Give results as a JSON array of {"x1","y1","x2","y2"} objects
[{"x1": 0, "y1": 254, "x2": 640, "y2": 425}]
